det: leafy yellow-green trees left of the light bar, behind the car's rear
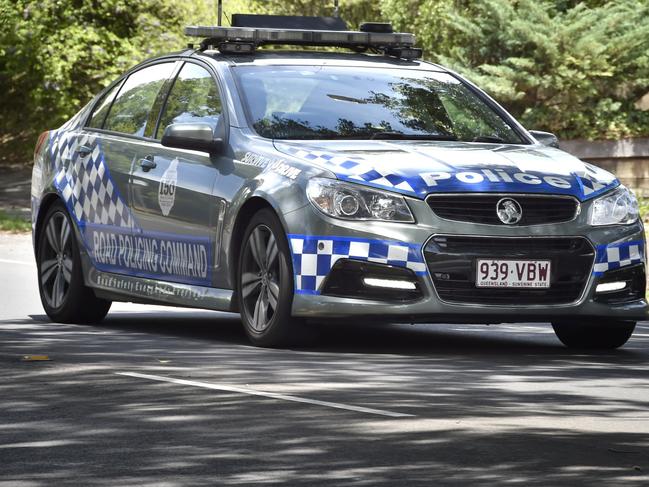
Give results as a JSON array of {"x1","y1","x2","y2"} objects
[{"x1": 0, "y1": 0, "x2": 209, "y2": 164}]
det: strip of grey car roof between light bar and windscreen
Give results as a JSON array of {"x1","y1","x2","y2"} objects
[{"x1": 194, "y1": 50, "x2": 446, "y2": 71}]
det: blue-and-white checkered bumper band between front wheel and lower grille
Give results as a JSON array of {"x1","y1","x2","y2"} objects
[{"x1": 288, "y1": 235, "x2": 426, "y2": 294}]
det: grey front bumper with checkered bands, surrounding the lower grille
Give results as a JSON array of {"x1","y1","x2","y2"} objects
[{"x1": 284, "y1": 200, "x2": 648, "y2": 323}]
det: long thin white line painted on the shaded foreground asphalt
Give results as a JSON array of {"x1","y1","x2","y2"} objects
[{"x1": 115, "y1": 372, "x2": 413, "y2": 418}]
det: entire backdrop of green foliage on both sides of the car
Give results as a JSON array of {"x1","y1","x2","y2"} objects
[{"x1": 0, "y1": 0, "x2": 649, "y2": 166}]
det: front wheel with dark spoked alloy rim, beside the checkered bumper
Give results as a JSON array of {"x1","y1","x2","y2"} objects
[{"x1": 237, "y1": 209, "x2": 300, "y2": 347}]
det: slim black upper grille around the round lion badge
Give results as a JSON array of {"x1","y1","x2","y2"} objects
[{"x1": 426, "y1": 194, "x2": 579, "y2": 226}]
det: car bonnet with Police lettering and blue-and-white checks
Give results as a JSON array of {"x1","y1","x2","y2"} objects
[{"x1": 275, "y1": 140, "x2": 620, "y2": 201}]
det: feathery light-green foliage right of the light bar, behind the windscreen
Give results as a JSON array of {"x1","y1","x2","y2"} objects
[{"x1": 382, "y1": 0, "x2": 649, "y2": 138}]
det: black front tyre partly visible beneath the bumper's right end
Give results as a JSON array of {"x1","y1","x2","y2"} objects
[{"x1": 552, "y1": 321, "x2": 635, "y2": 350}]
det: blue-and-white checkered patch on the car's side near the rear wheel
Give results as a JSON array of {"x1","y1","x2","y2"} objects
[{"x1": 49, "y1": 131, "x2": 133, "y2": 227}]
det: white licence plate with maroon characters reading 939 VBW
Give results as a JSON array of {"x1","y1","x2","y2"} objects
[{"x1": 475, "y1": 259, "x2": 550, "y2": 288}]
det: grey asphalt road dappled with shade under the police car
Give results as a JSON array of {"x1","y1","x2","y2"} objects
[{"x1": 0, "y1": 235, "x2": 649, "y2": 486}]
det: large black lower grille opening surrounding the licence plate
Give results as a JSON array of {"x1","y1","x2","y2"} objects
[{"x1": 424, "y1": 235, "x2": 595, "y2": 306}]
